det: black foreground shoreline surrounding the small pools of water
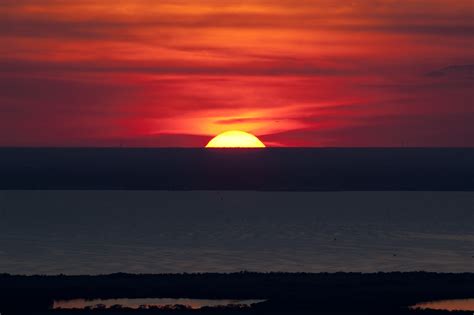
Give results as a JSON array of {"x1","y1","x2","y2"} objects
[{"x1": 0, "y1": 272, "x2": 474, "y2": 315}]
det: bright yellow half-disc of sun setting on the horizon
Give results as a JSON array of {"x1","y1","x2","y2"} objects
[{"x1": 206, "y1": 130, "x2": 265, "y2": 148}]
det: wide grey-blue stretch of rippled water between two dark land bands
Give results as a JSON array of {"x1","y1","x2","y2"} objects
[{"x1": 0, "y1": 190, "x2": 474, "y2": 275}]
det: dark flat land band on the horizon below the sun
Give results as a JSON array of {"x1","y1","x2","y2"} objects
[{"x1": 0, "y1": 148, "x2": 474, "y2": 191}]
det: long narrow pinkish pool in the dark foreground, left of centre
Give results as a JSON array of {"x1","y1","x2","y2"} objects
[{"x1": 53, "y1": 298, "x2": 263, "y2": 309}]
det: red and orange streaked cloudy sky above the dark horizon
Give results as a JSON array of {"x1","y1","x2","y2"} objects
[{"x1": 0, "y1": 0, "x2": 474, "y2": 147}]
